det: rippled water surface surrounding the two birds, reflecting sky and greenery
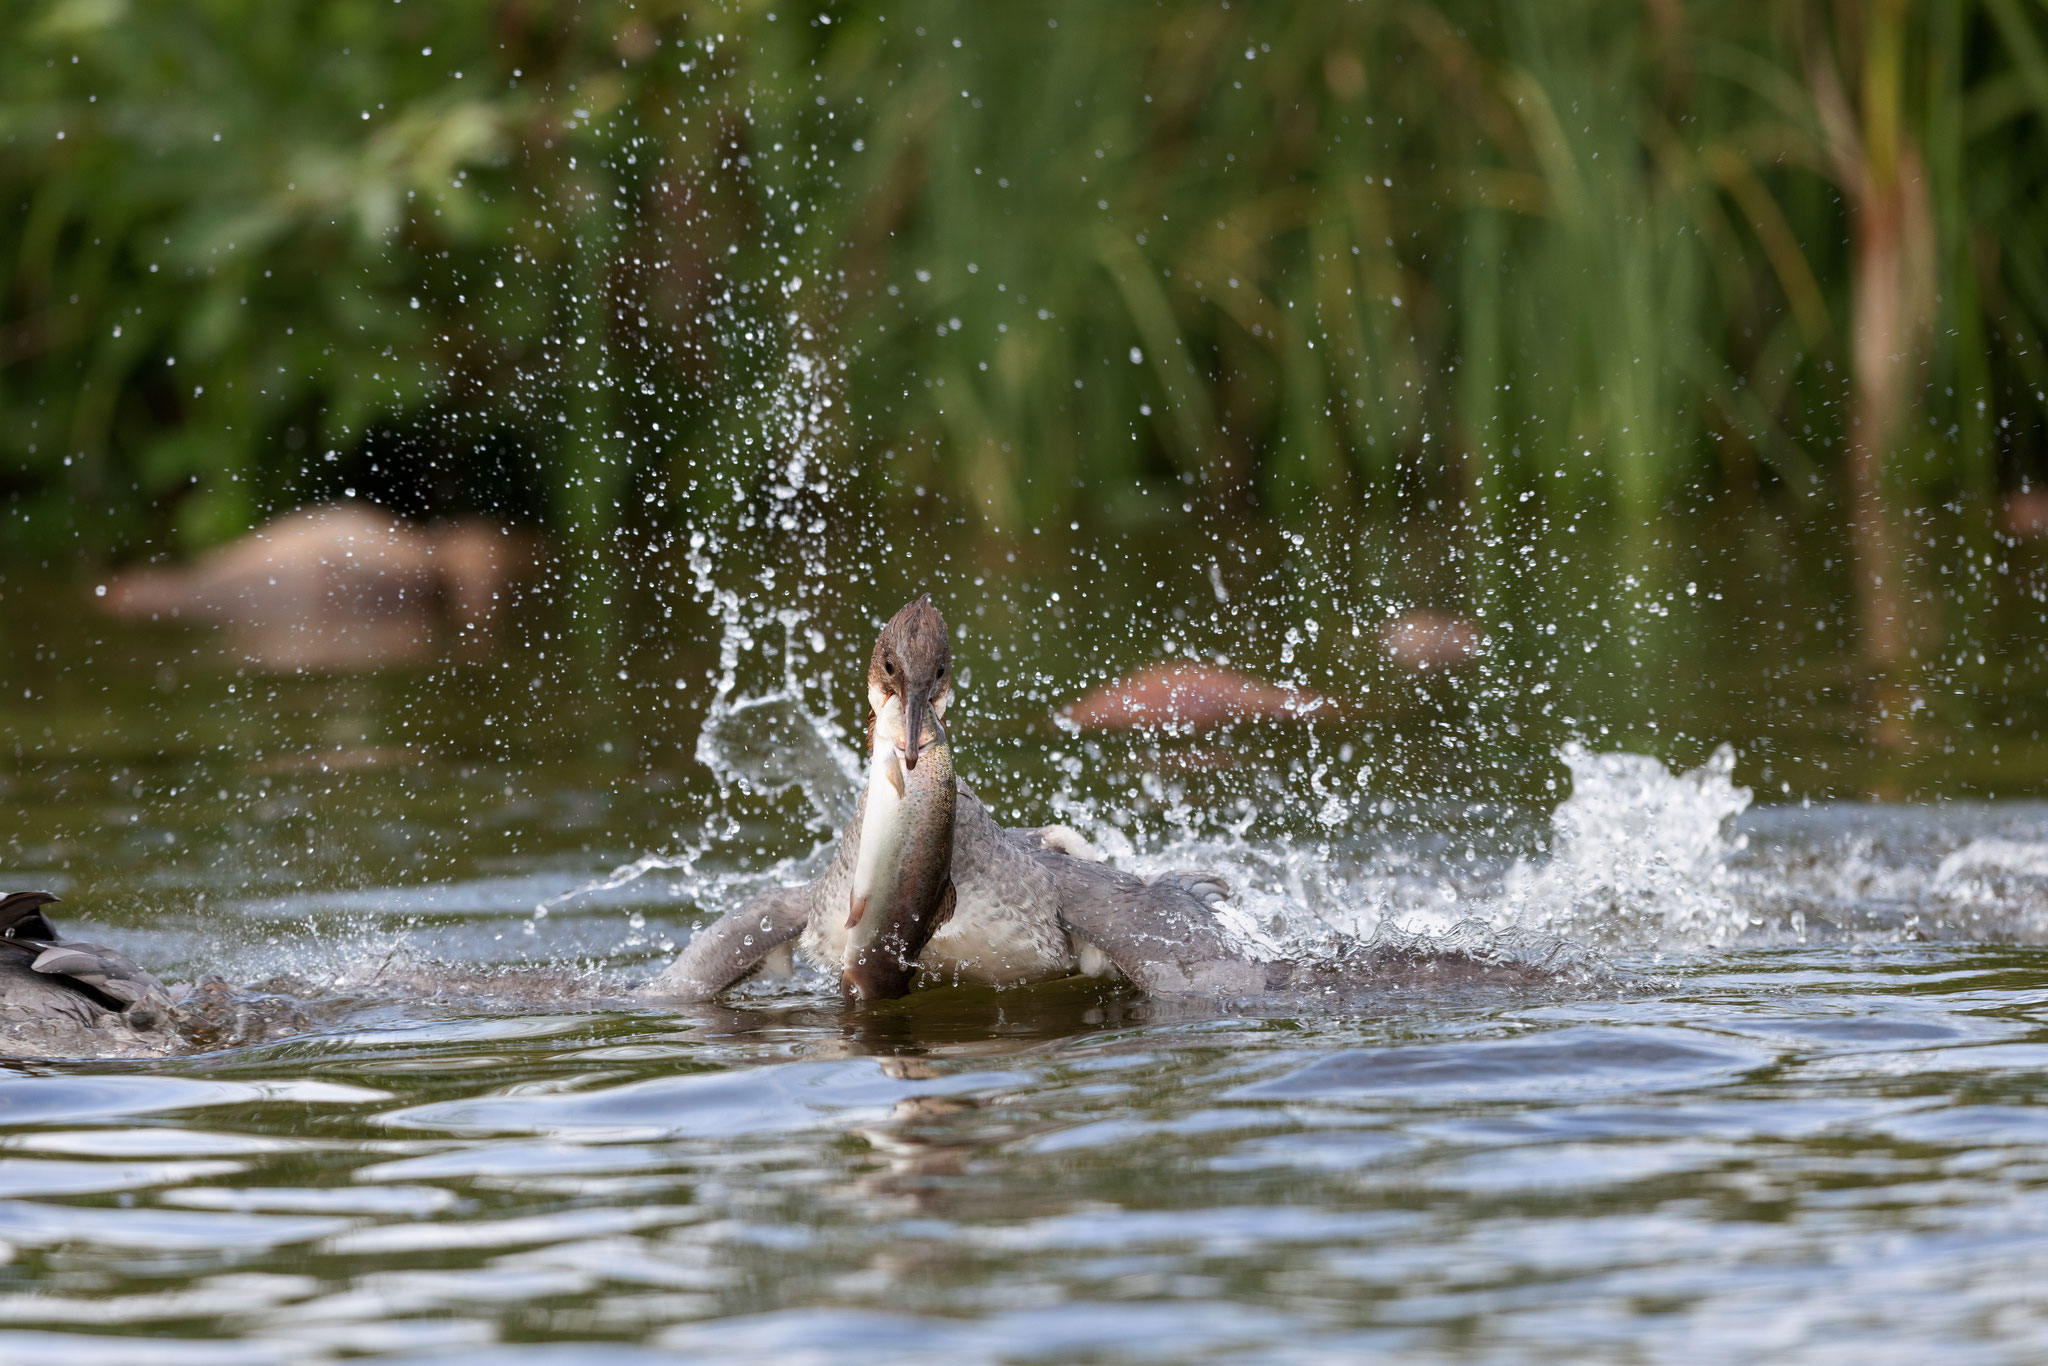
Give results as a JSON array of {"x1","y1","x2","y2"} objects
[{"x1": 12, "y1": 573, "x2": 2048, "y2": 1366}]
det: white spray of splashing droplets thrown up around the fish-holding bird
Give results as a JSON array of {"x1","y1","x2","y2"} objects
[{"x1": 307, "y1": 24, "x2": 2048, "y2": 995}]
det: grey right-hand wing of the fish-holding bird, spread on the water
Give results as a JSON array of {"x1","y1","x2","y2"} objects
[{"x1": 1034, "y1": 848, "x2": 1274, "y2": 997}]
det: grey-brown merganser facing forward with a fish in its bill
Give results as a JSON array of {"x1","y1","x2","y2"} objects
[{"x1": 647, "y1": 596, "x2": 1309, "y2": 1001}]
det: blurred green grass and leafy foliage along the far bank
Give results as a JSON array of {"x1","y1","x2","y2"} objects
[{"x1": 0, "y1": 0, "x2": 2048, "y2": 577}]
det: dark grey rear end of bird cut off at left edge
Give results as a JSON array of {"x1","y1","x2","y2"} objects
[{"x1": 0, "y1": 891, "x2": 172, "y2": 1032}]
